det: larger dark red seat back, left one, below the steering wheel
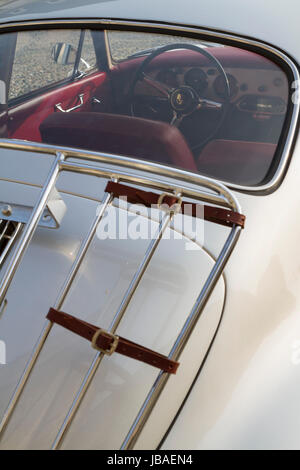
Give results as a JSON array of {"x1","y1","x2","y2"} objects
[{"x1": 40, "y1": 112, "x2": 197, "y2": 171}]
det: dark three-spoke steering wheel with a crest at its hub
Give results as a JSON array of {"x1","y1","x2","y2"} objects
[{"x1": 128, "y1": 43, "x2": 230, "y2": 150}]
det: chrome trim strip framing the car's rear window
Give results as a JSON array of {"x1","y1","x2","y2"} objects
[{"x1": 0, "y1": 18, "x2": 300, "y2": 195}]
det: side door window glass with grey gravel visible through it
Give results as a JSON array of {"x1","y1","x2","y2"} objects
[{"x1": 9, "y1": 30, "x2": 80, "y2": 100}]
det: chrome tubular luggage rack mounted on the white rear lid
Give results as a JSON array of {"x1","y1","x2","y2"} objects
[{"x1": 0, "y1": 140, "x2": 242, "y2": 450}]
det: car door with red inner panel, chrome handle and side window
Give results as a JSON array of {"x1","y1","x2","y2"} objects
[{"x1": 7, "y1": 30, "x2": 111, "y2": 142}]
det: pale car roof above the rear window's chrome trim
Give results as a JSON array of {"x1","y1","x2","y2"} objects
[{"x1": 0, "y1": 0, "x2": 300, "y2": 60}]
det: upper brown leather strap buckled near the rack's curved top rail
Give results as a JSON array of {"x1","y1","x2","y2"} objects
[{"x1": 105, "y1": 181, "x2": 246, "y2": 228}]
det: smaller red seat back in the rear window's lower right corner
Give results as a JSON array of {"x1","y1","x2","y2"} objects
[{"x1": 198, "y1": 140, "x2": 276, "y2": 185}]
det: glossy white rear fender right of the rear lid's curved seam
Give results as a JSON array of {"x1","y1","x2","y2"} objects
[{"x1": 164, "y1": 140, "x2": 300, "y2": 449}]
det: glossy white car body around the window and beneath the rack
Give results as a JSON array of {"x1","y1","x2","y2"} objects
[{"x1": 0, "y1": 0, "x2": 300, "y2": 450}]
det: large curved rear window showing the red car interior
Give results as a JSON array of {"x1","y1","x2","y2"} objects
[{"x1": 0, "y1": 30, "x2": 292, "y2": 186}]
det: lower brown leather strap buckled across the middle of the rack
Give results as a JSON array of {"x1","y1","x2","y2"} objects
[{"x1": 47, "y1": 308, "x2": 179, "y2": 374}]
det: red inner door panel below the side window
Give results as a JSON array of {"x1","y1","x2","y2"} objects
[{"x1": 8, "y1": 72, "x2": 112, "y2": 142}]
